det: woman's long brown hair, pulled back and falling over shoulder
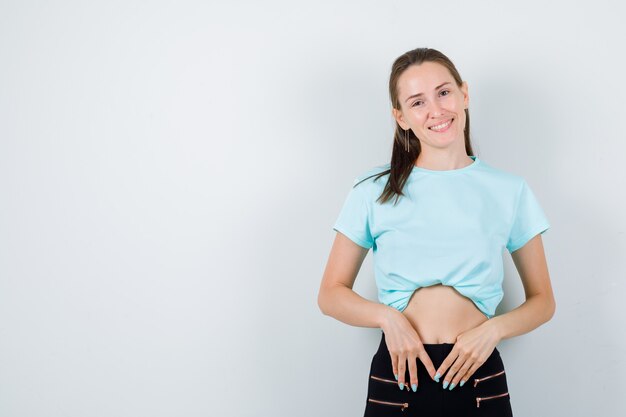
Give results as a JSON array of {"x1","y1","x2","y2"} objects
[{"x1": 355, "y1": 48, "x2": 474, "y2": 204}]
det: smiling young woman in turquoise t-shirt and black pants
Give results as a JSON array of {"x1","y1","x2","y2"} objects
[{"x1": 318, "y1": 48, "x2": 556, "y2": 417}]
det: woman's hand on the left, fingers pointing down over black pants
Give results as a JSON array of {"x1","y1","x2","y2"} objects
[{"x1": 381, "y1": 307, "x2": 435, "y2": 392}]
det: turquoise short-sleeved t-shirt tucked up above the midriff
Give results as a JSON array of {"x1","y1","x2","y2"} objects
[{"x1": 333, "y1": 156, "x2": 550, "y2": 318}]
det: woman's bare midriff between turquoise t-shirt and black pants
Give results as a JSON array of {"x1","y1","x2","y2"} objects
[{"x1": 402, "y1": 284, "x2": 488, "y2": 344}]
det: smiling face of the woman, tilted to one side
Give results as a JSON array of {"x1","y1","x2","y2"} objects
[{"x1": 393, "y1": 62, "x2": 469, "y2": 149}]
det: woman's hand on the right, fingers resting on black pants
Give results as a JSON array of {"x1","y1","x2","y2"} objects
[{"x1": 436, "y1": 320, "x2": 500, "y2": 389}]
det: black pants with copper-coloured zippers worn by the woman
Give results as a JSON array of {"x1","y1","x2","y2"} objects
[{"x1": 365, "y1": 331, "x2": 513, "y2": 417}]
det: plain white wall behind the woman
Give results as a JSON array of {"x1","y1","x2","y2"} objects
[{"x1": 0, "y1": 0, "x2": 626, "y2": 417}]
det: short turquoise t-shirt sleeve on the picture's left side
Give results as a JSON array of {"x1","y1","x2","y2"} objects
[{"x1": 333, "y1": 178, "x2": 374, "y2": 249}]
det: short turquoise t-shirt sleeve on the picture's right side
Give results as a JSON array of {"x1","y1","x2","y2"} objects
[{"x1": 506, "y1": 179, "x2": 550, "y2": 253}]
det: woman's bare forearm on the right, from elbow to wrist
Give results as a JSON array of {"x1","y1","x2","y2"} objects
[{"x1": 485, "y1": 294, "x2": 556, "y2": 340}]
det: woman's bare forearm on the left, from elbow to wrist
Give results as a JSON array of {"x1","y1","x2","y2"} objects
[{"x1": 318, "y1": 285, "x2": 391, "y2": 328}]
